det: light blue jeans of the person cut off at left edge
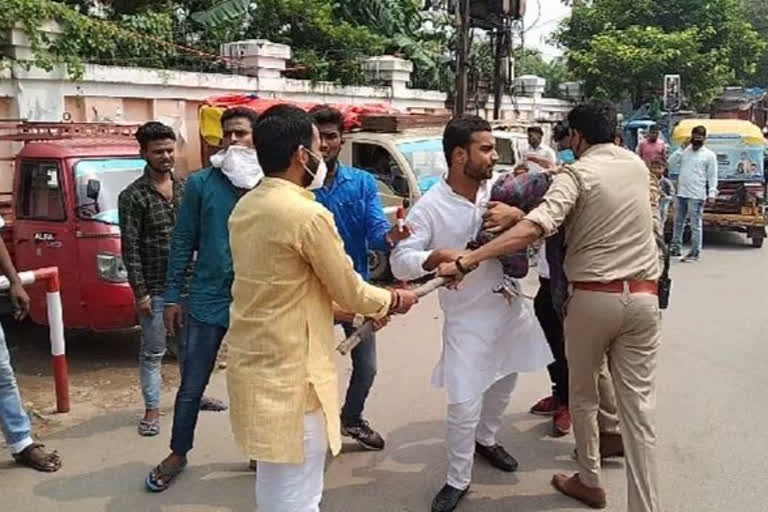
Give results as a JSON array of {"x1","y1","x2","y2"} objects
[{"x1": 0, "y1": 327, "x2": 33, "y2": 453}]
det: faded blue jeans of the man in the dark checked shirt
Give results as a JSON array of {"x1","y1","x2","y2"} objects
[{"x1": 139, "y1": 295, "x2": 172, "y2": 409}]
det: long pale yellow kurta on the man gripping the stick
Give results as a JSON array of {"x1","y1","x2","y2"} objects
[{"x1": 226, "y1": 178, "x2": 391, "y2": 464}]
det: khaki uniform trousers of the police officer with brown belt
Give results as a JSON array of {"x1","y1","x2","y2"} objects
[{"x1": 565, "y1": 287, "x2": 661, "y2": 512}]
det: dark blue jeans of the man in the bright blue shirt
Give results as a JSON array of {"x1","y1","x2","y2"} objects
[{"x1": 341, "y1": 324, "x2": 376, "y2": 426}]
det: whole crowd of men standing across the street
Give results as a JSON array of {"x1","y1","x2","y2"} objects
[{"x1": 0, "y1": 97, "x2": 728, "y2": 512}]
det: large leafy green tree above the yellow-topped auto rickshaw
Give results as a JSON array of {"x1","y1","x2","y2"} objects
[{"x1": 555, "y1": 0, "x2": 766, "y2": 108}]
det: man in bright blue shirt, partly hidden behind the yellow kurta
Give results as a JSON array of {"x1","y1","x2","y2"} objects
[{"x1": 310, "y1": 105, "x2": 410, "y2": 450}]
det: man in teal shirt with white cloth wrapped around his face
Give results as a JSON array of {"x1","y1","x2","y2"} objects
[{"x1": 145, "y1": 108, "x2": 261, "y2": 492}]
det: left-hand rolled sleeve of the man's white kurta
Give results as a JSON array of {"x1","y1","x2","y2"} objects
[{"x1": 389, "y1": 205, "x2": 432, "y2": 281}]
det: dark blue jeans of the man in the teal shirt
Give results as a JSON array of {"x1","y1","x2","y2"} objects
[{"x1": 171, "y1": 315, "x2": 227, "y2": 455}]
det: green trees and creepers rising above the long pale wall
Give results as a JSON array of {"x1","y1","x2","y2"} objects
[{"x1": 0, "y1": 0, "x2": 454, "y2": 90}]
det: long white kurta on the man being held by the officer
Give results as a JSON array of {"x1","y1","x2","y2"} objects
[{"x1": 390, "y1": 180, "x2": 552, "y2": 404}]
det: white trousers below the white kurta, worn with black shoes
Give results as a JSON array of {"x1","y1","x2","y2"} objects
[{"x1": 446, "y1": 373, "x2": 517, "y2": 489}]
